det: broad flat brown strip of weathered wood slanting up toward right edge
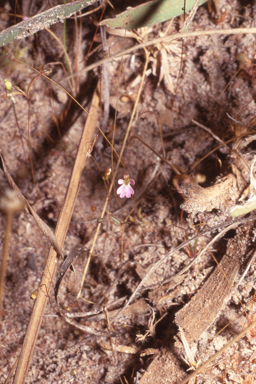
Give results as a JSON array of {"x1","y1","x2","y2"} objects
[{"x1": 175, "y1": 224, "x2": 250, "y2": 344}]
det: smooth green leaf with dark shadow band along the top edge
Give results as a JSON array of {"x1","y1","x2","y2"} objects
[{"x1": 100, "y1": 0, "x2": 207, "y2": 29}]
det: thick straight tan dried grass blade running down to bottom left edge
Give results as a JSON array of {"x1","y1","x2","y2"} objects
[{"x1": 14, "y1": 87, "x2": 99, "y2": 384}]
